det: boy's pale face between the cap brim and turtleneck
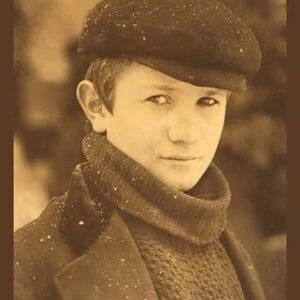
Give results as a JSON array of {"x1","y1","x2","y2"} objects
[{"x1": 102, "y1": 63, "x2": 227, "y2": 191}]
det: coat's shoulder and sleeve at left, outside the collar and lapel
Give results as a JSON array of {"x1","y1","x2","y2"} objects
[{"x1": 14, "y1": 195, "x2": 75, "y2": 299}]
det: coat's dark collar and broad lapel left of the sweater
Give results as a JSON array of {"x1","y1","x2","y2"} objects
[{"x1": 54, "y1": 166, "x2": 158, "y2": 300}]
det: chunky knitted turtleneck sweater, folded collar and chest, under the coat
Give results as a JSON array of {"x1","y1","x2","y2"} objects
[{"x1": 83, "y1": 133, "x2": 244, "y2": 299}]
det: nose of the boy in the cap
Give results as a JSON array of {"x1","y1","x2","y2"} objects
[{"x1": 168, "y1": 116, "x2": 201, "y2": 144}]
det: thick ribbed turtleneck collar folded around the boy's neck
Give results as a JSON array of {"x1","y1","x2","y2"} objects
[{"x1": 82, "y1": 133, "x2": 231, "y2": 245}]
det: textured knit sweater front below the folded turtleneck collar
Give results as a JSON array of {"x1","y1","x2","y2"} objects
[{"x1": 126, "y1": 218, "x2": 244, "y2": 300}]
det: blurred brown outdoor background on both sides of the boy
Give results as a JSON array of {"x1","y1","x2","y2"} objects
[{"x1": 14, "y1": 0, "x2": 287, "y2": 300}]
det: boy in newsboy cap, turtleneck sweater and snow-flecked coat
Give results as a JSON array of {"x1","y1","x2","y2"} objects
[{"x1": 15, "y1": 0, "x2": 264, "y2": 300}]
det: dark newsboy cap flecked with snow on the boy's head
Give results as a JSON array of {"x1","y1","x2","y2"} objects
[{"x1": 78, "y1": 0, "x2": 261, "y2": 91}]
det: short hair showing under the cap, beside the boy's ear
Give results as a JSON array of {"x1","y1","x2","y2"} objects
[{"x1": 85, "y1": 57, "x2": 132, "y2": 113}]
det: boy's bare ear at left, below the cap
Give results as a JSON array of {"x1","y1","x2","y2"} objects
[{"x1": 76, "y1": 80, "x2": 109, "y2": 133}]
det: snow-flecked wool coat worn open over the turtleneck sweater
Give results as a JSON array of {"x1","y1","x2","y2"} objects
[{"x1": 14, "y1": 165, "x2": 265, "y2": 300}]
